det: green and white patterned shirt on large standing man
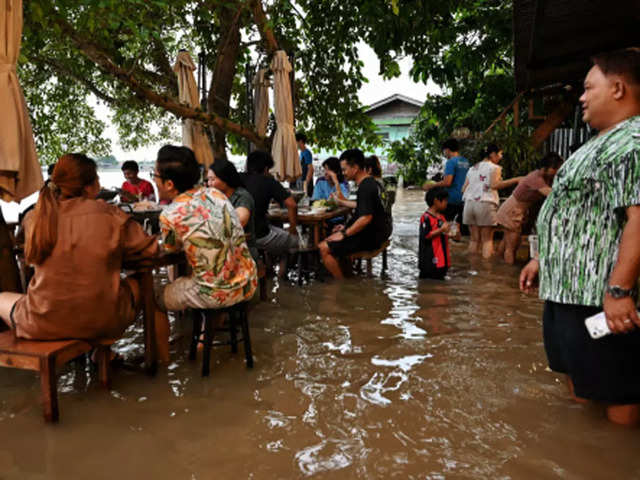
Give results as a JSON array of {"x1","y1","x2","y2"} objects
[{"x1": 537, "y1": 116, "x2": 640, "y2": 307}]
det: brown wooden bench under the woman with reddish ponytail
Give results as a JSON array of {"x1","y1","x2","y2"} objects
[{"x1": 0, "y1": 331, "x2": 113, "y2": 422}]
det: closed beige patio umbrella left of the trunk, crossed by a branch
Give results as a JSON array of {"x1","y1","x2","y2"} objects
[{"x1": 173, "y1": 50, "x2": 213, "y2": 168}]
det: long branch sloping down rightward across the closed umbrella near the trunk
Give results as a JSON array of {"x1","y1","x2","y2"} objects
[{"x1": 56, "y1": 18, "x2": 265, "y2": 145}]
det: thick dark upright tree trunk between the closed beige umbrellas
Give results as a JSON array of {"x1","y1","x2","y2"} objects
[{"x1": 207, "y1": 6, "x2": 241, "y2": 159}]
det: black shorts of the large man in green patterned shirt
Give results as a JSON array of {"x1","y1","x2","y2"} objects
[{"x1": 542, "y1": 301, "x2": 640, "y2": 404}]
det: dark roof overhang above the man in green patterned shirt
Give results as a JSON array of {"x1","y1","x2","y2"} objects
[{"x1": 513, "y1": 0, "x2": 640, "y2": 92}]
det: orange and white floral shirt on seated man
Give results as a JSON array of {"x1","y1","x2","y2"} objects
[{"x1": 160, "y1": 187, "x2": 257, "y2": 307}]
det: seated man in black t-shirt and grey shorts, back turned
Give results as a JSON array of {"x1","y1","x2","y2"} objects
[{"x1": 241, "y1": 151, "x2": 298, "y2": 255}]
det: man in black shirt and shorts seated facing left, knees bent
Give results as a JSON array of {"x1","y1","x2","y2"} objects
[{"x1": 319, "y1": 149, "x2": 391, "y2": 279}]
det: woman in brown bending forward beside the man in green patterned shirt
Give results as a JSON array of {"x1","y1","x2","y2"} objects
[{"x1": 496, "y1": 152, "x2": 564, "y2": 264}]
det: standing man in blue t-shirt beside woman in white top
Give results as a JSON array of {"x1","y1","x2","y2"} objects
[{"x1": 422, "y1": 138, "x2": 469, "y2": 237}]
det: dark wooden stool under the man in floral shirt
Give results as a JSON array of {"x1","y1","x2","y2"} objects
[{"x1": 189, "y1": 302, "x2": 253, "y2": 377}]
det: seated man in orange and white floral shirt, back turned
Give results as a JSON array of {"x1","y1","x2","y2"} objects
[{"x1": 153, "y1": 145, "x2": 258, "y2": 311}]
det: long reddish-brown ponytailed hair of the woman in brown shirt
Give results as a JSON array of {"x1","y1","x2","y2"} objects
[{"x1": 25, "y1": 153, "x2": 98, "y2": 265}]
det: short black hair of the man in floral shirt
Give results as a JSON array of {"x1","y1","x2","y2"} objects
[{"x1": 156, "y1": 145, "x2": 200, "y2": 193}]
